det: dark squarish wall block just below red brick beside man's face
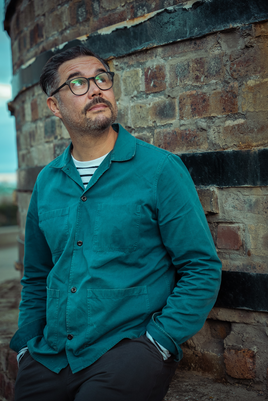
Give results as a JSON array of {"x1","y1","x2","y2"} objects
[{"x1": 150, "y1": 98, "x2": 177, "y2": 124}]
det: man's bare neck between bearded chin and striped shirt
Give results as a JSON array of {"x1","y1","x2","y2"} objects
[{"x1": 70, "y1": 126, "x2": 117, "y2": 161}]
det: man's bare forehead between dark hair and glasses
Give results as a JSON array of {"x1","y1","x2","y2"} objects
[{"x1": 58, "y1": 56, "x2": 105, "y2": 80}]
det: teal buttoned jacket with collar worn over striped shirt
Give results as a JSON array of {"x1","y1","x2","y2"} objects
[{"x1": 10, "y1": 125, "x2": 221, "y2": 373}]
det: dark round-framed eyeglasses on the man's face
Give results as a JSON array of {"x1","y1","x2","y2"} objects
[{"x1": 50, "y1": 72, "x2": 114, "y2": 96}]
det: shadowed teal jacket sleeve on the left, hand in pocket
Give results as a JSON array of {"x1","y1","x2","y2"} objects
[{"x1": 10, "y1": 184, "x2": 53, "y2": 352}]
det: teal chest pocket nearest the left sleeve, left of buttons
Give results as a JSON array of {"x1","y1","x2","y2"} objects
[{"x1": 39, "y1": 208, "x2": 69, "y2": 253}]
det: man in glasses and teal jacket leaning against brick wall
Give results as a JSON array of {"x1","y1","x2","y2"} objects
[{"x1": 11, "y1": 46, "x2": 221, "y2": 401}]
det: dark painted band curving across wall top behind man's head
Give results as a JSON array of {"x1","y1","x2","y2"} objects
[{"x1": 10, "y1": 0, "x2": 268, "y2": 98}]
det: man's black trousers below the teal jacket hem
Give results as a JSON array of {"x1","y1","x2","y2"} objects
[{"x1": 15, "y1": 335, "x2": 177, "y2": 401}]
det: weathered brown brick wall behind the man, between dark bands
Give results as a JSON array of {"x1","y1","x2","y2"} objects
[{"x1": 5, "y1": 0, "x2": 268, "y2": 396}]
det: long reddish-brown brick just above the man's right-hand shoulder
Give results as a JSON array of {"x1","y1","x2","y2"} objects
[{"x1": 154, "y1": 128, "x2": 208, "y2": 153}]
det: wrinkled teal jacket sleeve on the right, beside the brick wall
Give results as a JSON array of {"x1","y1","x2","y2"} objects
[{"x1": 147, "y1": 154, "x2": 221, "y2": 360}]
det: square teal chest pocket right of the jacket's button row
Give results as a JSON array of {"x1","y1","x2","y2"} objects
[{"x1": 93, "y1": 204, "x2": 141, "y2": 252}]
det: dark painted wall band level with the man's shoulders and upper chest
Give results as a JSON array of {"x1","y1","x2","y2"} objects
[{"x1": 18, "y1": 149, "x2": 268, "y2": 191}]
